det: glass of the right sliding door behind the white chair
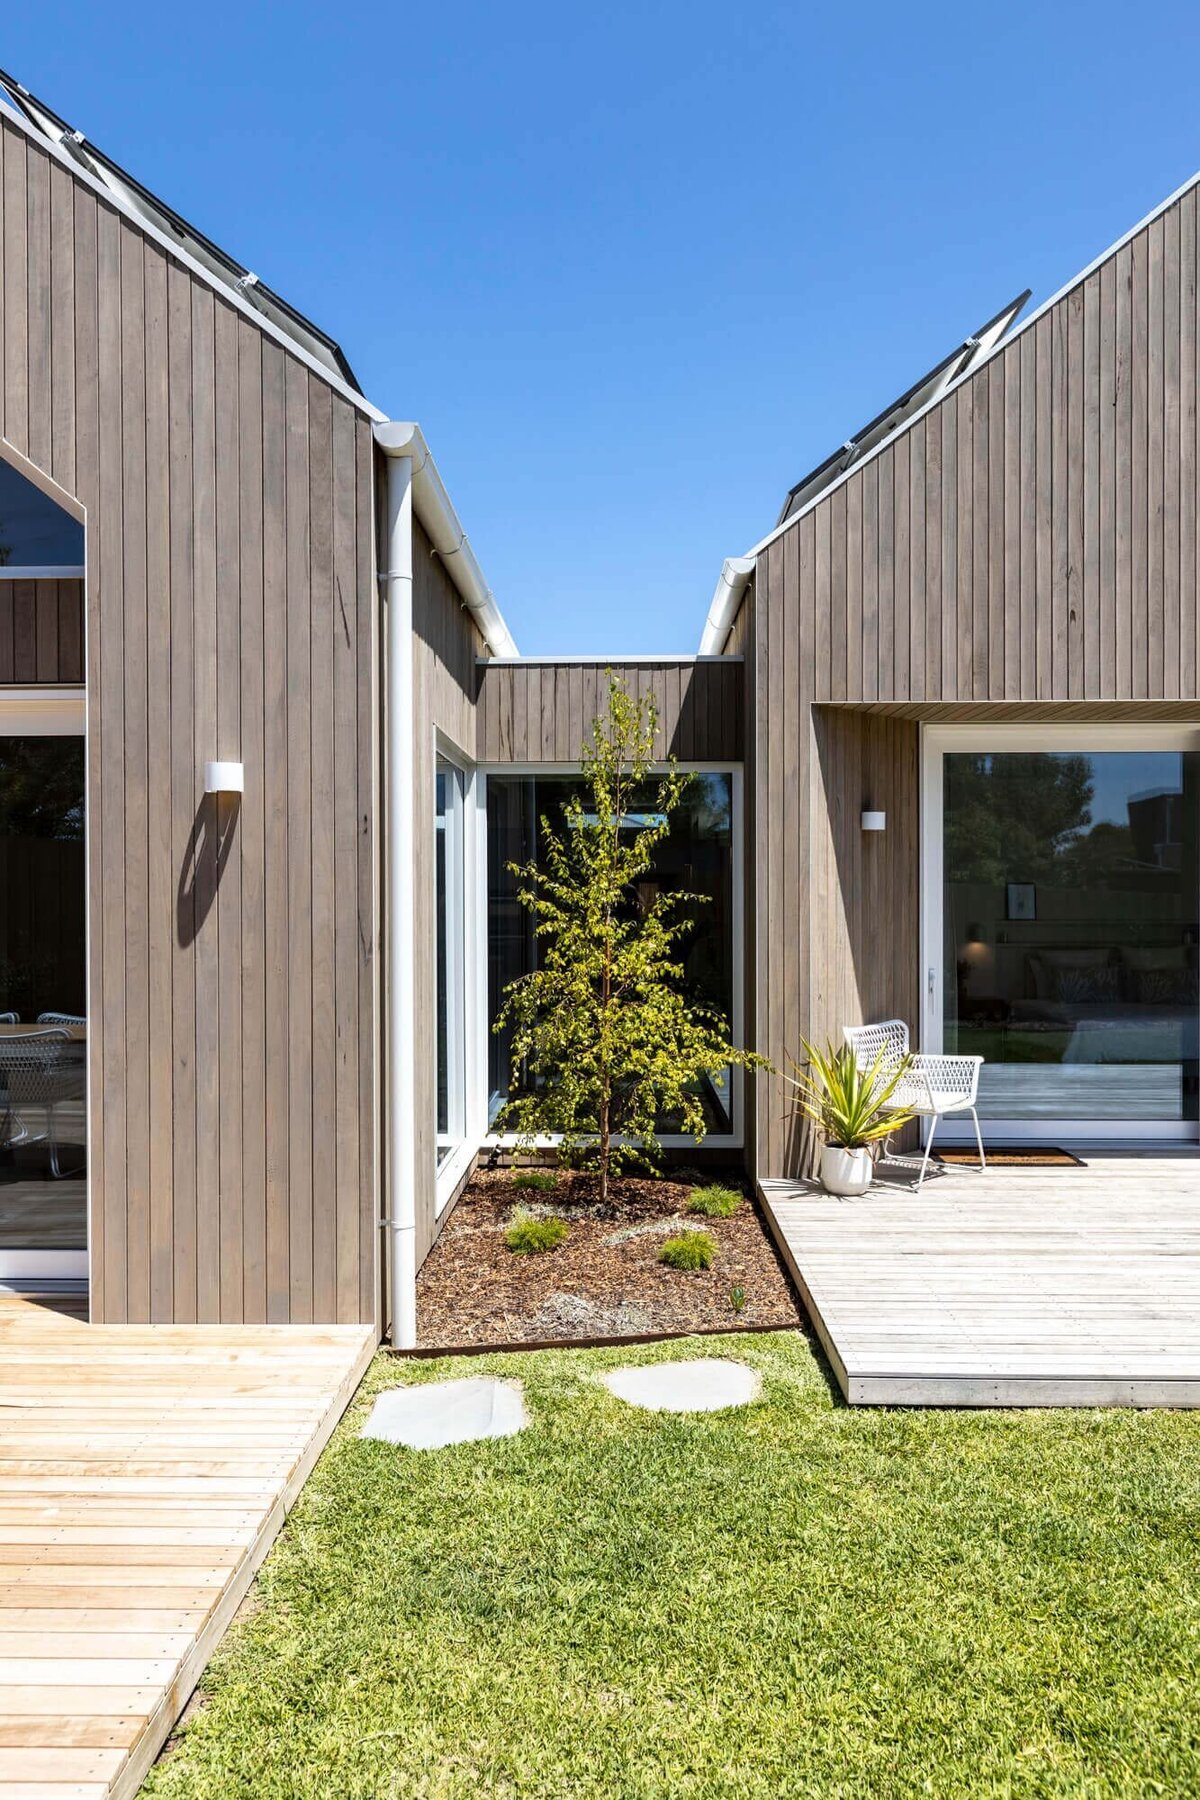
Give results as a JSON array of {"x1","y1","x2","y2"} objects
[{"x1": 927, "y1": 731, "x2": 1200, "y2": 1138}]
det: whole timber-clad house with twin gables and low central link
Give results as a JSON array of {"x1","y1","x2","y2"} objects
[{"x1": 0, "y1": 63, "x2": 1200, "y2": 1343}]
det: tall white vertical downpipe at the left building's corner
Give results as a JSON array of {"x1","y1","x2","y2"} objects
[{"x1": 385, "y1": 432, "x2": 417, "y2": 1350}]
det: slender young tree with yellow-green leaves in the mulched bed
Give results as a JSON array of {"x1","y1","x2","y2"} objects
[{"x1": 497, "y1": 671, "x2": 766, "y2": 1201}]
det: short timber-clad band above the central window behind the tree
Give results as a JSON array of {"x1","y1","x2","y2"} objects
[{"x1": 479, "y1": 657, "x2": 743, "y2": 763}]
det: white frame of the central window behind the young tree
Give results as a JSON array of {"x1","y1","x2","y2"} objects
[{"x1": 475, "y1": 761, "x2": 745, "y2": 1150}]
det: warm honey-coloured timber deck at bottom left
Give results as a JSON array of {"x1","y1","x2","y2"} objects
[{"x1": 0, "y1": 1294, "x2": 374, "y2": 1800}]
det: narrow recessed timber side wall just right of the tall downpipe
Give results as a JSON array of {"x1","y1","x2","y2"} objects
[{"x1": 412, "y1": 517, "x2": 486, "y2": 1265}]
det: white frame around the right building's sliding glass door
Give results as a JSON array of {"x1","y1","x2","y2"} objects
[{"x1": 916, "y1": 718, "x2": 1200, "y2": 1143}]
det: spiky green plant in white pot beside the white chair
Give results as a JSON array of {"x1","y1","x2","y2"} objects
[{"x1": 790, "y1": 1042, "x2": 912, "y2": 1195}]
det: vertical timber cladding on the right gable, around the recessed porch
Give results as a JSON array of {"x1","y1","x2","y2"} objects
[{"x1": 752, "y1": 185, "x2": 1200, "y2": 1175}]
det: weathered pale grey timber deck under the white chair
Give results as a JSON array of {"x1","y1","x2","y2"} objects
[{"x1": 759, "y1": 1150, "x2": 1200, "y2": 1406}]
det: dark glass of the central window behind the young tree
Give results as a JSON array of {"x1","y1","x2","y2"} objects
[{"x1": 488, "y1": 770, "x2": 734, "y2": 1134}]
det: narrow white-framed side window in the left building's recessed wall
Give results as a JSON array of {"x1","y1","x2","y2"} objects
[{"x1": 434, "y1": 758, "x2": 466, "y2": 1165}]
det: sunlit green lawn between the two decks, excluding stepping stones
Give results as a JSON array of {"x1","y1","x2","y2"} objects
[{"x1": 146, "y1": 1334, "x2": 1200, "y2": 1800}]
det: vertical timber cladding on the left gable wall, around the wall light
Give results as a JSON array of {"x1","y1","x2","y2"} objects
[{"x1": 0, "y1": 117, "x2": 376, "y2": 1321}]
